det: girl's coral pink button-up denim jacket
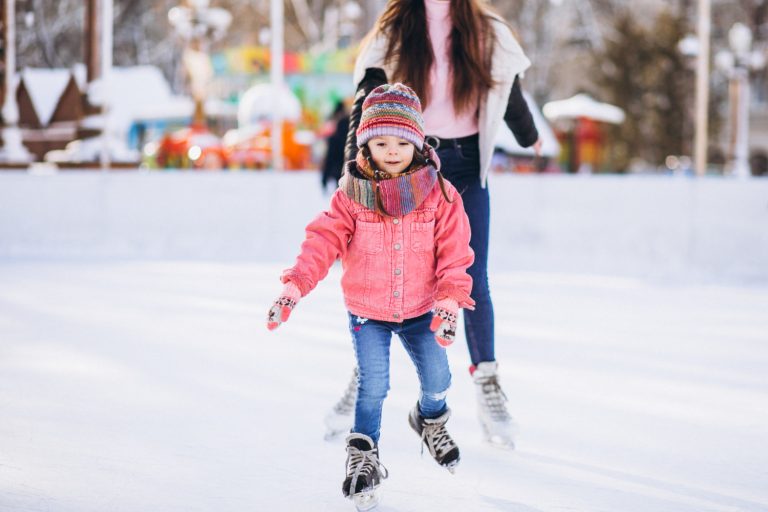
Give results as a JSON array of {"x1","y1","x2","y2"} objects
[{"x1": 281, "y1": 181, "x2": 475, "y2": 322}]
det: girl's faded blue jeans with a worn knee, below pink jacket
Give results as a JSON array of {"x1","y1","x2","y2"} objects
[{"x1": 349, "y1": 313, "x2": 451, "y2": 443}]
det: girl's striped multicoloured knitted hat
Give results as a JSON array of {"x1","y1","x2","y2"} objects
[{"x1": 357, "y1": 83, "x2": 424, "y2": 151}]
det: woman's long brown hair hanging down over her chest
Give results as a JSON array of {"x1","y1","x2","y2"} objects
[{"x1": 371, "y1": 0, "x2": 495, "y2": 112}]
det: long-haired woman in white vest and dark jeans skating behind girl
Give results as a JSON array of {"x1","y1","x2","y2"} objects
[{"x1": 326, "y1": 0, "x2": 541, "y2": 447}]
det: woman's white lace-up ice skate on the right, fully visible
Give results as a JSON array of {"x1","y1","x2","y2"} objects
[{"x1": 471, "y1": 361, "x2": 515, "y2": 450}]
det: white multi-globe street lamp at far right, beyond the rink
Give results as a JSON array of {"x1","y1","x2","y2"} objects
[{"x1": 715, "y1": 23, "x2": 765, "y2": 178}]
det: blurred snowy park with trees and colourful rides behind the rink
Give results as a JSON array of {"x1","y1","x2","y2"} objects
[{"x1": 0, "y1": 0, "x2": 768, "y2": 176}]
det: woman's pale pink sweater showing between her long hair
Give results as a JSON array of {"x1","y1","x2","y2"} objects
[{"x1": 424, "y1": 0, "x2": 478, "y2": 139}]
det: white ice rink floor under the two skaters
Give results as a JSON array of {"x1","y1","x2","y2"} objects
[{"x1": 0, "y1": 259, "x2": 768, "y2": 512}]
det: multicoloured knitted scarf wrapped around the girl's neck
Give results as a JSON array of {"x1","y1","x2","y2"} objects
[{"x1": 339, "y1": 145, "x2": 440, "y2": 217}]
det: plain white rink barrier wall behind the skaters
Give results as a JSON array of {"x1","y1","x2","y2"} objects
[{"x1": 0, "y1": 171, "x2": 768, "y2": 284}]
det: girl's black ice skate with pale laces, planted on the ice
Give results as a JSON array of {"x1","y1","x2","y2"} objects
[{"x1": 341, "y1": 434, "x2": 387, "y2": 510}]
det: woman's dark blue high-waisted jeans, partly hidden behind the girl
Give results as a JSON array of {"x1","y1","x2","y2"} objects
[{"x1": 437, "y1": 136, "x2": 496, "y2": 365}]
